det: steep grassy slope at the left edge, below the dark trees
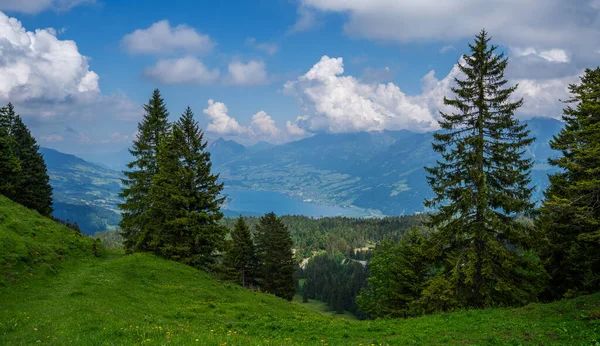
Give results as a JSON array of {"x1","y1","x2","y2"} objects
[{"x1": 0, "y1": 195, "x2": 92, "y2": 286}]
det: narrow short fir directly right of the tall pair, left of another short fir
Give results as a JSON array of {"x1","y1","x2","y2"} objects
[{"x1": 223, "y1": 216, "x2": 258, "y2": 287}]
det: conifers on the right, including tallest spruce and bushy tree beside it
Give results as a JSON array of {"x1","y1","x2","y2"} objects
[{"x1": 357, "y1": 31, "x2": 600, "y2": 318}]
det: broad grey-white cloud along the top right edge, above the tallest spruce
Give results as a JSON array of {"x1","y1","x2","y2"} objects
[{"x1": 299, "y1": 0, "x2": 600, "y2": 62}]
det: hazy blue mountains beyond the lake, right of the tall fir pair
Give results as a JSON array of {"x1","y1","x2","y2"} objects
[{"x1": 212, "y1": 118, "x2": 562, "y2": 215}]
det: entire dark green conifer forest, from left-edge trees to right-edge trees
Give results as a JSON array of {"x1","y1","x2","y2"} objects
[{"x1": 0, "y1": 31, "x2": 600, "y2": 324}]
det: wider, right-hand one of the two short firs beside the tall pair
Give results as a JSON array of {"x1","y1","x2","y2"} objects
[{"x1": 255, "y1": 213, "x2": 296, "y2": 300}]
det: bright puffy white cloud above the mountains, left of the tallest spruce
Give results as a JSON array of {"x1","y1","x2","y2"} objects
[{"x1": 284, "y1": 56, "x2": 437, "y2": 132}]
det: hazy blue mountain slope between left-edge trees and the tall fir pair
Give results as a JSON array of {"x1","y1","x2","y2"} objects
[{"x1": 40, "y1": 147, "x2": 121, "y2": 234}]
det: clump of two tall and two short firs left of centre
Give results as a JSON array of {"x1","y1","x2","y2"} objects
[{"x1": 119, "y1": 89, "x2": 295, "y2": 300}]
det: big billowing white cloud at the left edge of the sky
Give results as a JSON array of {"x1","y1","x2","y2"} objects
[{"x1": 0, "y1": 12, "x2": 100, "y2": 103}]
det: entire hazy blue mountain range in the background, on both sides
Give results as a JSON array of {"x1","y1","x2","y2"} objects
[{"x1": 42, "y1": 118, "x2": 562, "y2": 233}]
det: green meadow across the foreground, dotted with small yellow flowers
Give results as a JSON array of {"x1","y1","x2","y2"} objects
[{"x1": 0, "y1": 196, "x2": 600, "y2": 345}]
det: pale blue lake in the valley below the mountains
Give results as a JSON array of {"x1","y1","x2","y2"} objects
[{"x1": 223, "y1": 189, "x2": 368, "y2": 217}]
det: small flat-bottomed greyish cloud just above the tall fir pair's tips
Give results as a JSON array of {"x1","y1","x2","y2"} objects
[{"x1": 144, "y1": 57, "x2": 219, "y2": 84}]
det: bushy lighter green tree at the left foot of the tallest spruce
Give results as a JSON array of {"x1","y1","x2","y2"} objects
[{"x1": 357, "y1": 229, "x2": 431, "y2": 318}]
